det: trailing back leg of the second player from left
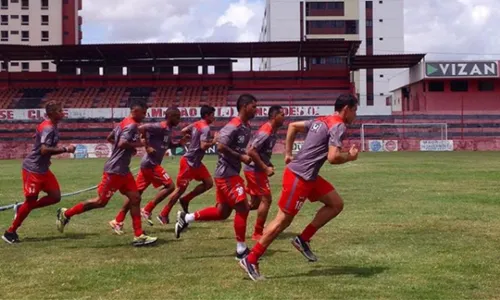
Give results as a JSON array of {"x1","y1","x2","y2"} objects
[{"x1": 56, "y1": 173, "x2": 116, "y2": 233}]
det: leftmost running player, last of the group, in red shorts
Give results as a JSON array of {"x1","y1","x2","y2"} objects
[{"x1": 2, "y1": 101, "x2": 75, "y2": 244}]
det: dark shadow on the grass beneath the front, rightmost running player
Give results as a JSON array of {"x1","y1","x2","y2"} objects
[{"x1": 269, "y1": 266, "x2": 389, "y2": 278}]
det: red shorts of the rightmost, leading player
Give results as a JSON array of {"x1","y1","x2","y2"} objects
[{"x1": 278, "y1": 168, "x2": 335, "y2": 216}]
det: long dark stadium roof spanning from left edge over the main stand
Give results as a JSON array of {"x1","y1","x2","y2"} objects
[{"x1": 0, "y1": 40, "x2": 361, "y2": 62}]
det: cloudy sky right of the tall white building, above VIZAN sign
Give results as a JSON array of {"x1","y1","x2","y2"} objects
[{"x1": 405, "y1": 0, "x2": 500, "y2": 60}]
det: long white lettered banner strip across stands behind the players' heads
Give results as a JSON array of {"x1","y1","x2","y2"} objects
[{"x1": 0, "y1": 106, "x2": 334, "y2": 121}]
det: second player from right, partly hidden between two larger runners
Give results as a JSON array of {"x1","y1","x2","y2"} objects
[{"x1": 243, "y1": 105, "x2": 285, "y2": 241}]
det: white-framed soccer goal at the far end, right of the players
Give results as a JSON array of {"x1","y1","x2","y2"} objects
[{"x1": 360, "y1": 123, "x2": 453, "y2": 152}]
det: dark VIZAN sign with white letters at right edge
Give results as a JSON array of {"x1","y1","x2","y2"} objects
[{"x1": 425, "y1": 61, "x2": 498, "y2": 77}]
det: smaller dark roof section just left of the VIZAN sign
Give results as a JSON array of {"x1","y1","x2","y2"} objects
[{"x1": 351, "y1": 54, "x2": 425, "y2": 70}]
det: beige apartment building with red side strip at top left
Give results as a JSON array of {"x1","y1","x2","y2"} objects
[{"x1": 0, "y1": 0, "x2": 82, "y2": 72}]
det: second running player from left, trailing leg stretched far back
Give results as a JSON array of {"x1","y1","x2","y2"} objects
[{"x1": 56, "y1": 101, "x2": 157, "y2": 246}]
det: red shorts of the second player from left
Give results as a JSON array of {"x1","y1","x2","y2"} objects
[{"x1": 97, "y1": 172, "x2": 138, "y2": 201}]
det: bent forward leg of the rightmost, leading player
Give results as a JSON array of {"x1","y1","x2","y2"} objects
[{"x1": 292, "y1": 177, "x2": 344, "y2": 262}]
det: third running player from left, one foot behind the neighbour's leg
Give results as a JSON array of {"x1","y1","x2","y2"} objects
[{"x1": 109, "y1": 108, "x2": 185, "y2": 235}]
